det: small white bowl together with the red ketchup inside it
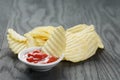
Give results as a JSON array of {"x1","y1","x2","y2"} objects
[{"x1": 18, "y1": 47, "x2": 64, "y2": 71}]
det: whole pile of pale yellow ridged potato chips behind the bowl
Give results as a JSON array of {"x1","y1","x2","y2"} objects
[{"x1": 7, "y1": 24, "x2": 104, "y2": 62}]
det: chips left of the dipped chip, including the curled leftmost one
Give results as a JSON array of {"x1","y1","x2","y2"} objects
[{"x1": 7, "y1": 26, "x2": 55, "y2": 54}]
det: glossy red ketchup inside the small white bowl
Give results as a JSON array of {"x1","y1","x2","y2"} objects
[{"x1": 26, "y1": 50, "x2": 58, "y2": 64}]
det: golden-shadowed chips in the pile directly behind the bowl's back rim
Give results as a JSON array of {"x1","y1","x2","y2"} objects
[{"x1": 24, "y1": 26, "x2": 55, "y2": 47}]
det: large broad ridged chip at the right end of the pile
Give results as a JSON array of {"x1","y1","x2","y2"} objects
[{"x1": 65, "y1": 25, "x2": 103, "y2": 62}]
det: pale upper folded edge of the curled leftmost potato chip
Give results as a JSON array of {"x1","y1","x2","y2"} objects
[{"x1": 8, "y1": 28, "x2": 27, "y2": 42}]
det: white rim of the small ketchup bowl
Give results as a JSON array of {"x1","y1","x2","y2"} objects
[{"x1": 18, "y1": 47, "x2": 64, "y2": 66}]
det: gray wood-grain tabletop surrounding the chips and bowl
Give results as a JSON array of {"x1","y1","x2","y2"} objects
[{"x1": 0, "y1": 0, "x2": 120, "y2": 80}]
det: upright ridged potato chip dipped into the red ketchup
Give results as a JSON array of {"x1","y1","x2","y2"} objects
[{"x1": 42, "y1": 26, "x2": 66, "y2": 57}]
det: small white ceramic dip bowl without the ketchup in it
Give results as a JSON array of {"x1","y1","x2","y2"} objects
[{"x1": 18, "y1": 47, "x2": 64, "y2": 71}]
